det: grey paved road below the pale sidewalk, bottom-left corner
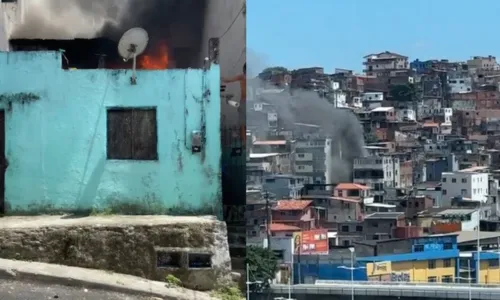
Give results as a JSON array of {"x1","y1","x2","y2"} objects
[{"x1": 0, "y1": 280, "x2": 157, "y2": 300}]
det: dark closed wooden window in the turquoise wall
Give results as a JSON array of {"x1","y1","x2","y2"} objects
[{"x1": 107, "y1": 108, "x2": 158, "y2": 160}]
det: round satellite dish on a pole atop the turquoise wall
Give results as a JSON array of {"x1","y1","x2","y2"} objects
[{"x1": 118, "y1": 27, "x2": 149, "y2": 84}]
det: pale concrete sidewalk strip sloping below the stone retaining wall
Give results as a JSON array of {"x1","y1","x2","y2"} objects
[{"x1": 0, "y1": 259, "x2": 215, "y2": 300}]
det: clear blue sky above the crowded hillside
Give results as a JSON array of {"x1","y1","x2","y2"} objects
[{"x1": 247, "y1": 0, "x2": 500, "y2": 73}]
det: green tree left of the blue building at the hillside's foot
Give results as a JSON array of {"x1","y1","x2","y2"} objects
[{"x1": 246, "y1": 246, "x2": 278, "y2": 290}]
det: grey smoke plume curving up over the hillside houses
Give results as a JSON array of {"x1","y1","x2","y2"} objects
[{"x1": 250, "y1": 74, "x2": 366, "y2": 183}]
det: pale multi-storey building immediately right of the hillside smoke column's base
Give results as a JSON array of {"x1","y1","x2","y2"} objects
[{"x1": 353, "y1": 156, "x2": 401, "y2": 203}]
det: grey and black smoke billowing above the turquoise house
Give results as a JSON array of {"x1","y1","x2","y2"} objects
[{"x1": 9, "y1": 0, "x2": 208, "y2": 68}]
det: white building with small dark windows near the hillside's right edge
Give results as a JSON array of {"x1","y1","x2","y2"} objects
[{"x1": 441, "y1": 171, "x2": 489, "y2": 206}]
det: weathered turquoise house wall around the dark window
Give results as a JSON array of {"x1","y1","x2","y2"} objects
[{"x1": 0, "y1": 52, "x2": 222, "y2": 216}]
